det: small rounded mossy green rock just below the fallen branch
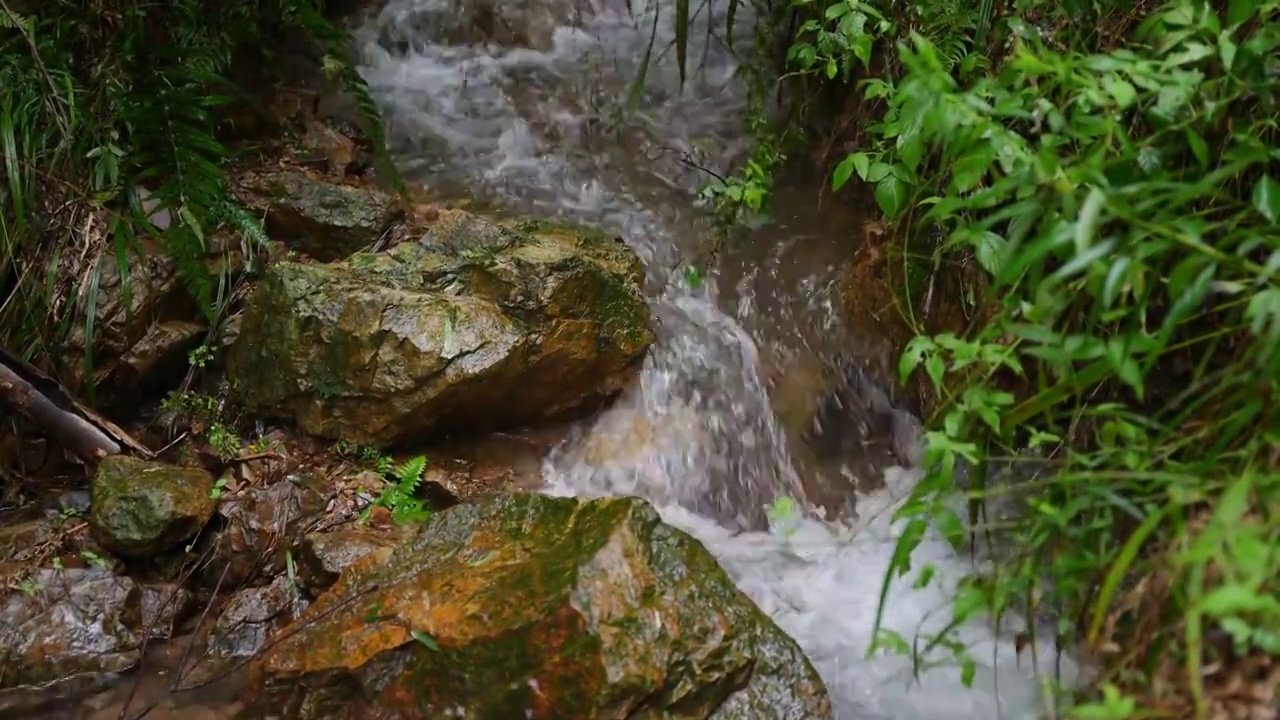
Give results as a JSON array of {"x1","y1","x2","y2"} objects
[{"x1": 90, "y1": 455, "x2": 215, "y2": 557}]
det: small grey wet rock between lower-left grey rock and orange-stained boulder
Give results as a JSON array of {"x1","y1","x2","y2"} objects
[{"x1": 209, "y1": 575, "x2": 307, "y2": 657}]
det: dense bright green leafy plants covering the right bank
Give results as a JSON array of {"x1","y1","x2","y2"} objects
[{"x1": 709, "y1": 0, "x2": 1280, "y2": 719}]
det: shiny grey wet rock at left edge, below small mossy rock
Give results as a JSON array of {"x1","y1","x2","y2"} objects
[{"x1": 0, "y1": 569, "x2": 142, "y2": 688}]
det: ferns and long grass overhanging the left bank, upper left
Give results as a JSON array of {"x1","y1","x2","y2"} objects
[{"x1": 0, "y1": 0, "x2": 383, "y2": 374}]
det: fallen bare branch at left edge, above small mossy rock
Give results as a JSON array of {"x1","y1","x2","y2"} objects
[{"x1": 0, "y1": 348, "x2": 154, "y2": 461}]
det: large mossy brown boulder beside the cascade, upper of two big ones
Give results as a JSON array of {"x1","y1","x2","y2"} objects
[{"x1": 228, "y1": 210, "x2": 653, "y2": 447}]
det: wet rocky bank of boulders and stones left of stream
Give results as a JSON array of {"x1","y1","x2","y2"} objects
[{"x1": 0, "y1": 3, "x2": 967, "y2": 720}]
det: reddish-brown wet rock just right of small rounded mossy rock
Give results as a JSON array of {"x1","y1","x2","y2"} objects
[{"x1": 201, "y1": 475, "x2": 328, "y2": 587}]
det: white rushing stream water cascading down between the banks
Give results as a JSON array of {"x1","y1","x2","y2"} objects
[{"x1": 357, "y1": 0, "x2": 1071, "y2": 720}]
